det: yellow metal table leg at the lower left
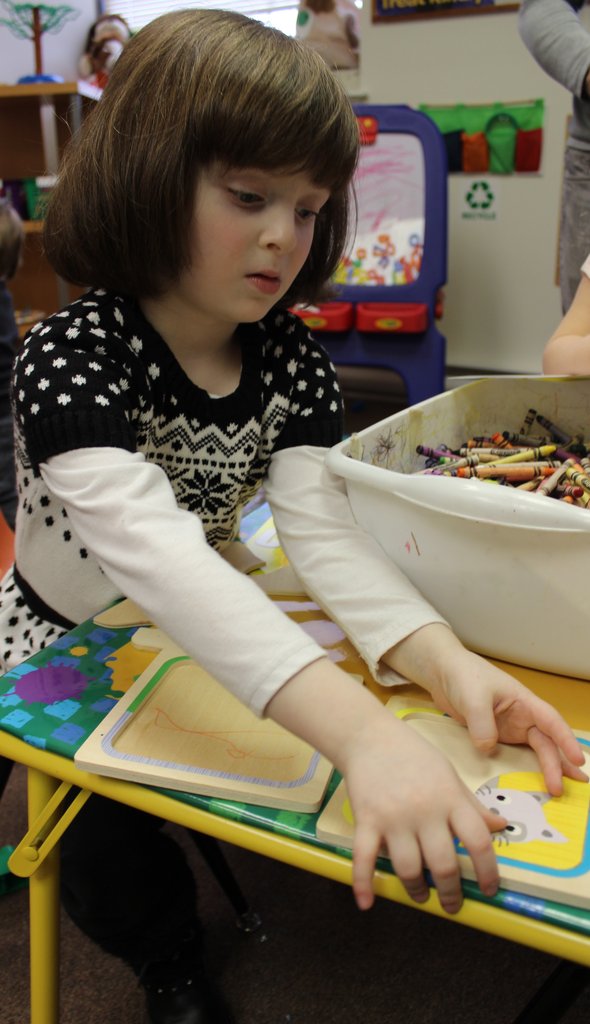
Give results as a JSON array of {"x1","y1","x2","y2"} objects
[{"x1": 28, "y1": 768, "x2": 59, "y2": 1024}]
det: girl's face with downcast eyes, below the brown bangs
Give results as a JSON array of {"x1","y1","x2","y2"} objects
[{"x1": 169, "y1": 166, "x2": 330, "y2": 330}]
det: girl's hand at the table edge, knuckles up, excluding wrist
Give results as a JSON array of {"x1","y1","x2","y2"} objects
[{"x1": 342, "y1": 716, "x2": 506, "y2": 913}]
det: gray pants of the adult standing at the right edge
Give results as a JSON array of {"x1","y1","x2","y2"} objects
[{"x1": 559, "y1": 145, "x2": 590, "y2": 312}]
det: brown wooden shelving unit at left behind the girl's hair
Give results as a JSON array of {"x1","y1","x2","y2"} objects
[{"x1": 0, "y1": 82, "x2": 100, "y2": 313}]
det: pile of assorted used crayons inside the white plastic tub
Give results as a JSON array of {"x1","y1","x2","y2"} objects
[{"x1": 416, "y1": 409, "x2": 590, "y2": 508}]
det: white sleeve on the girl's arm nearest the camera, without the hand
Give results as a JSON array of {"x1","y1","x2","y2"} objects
[{"x1": 41, "y1": 447, "x2": 325, "y2": 715}]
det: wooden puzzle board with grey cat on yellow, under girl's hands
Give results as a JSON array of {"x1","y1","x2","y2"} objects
[{"x1": 317, "y1": 697, "x2": 590, "y2": 908}]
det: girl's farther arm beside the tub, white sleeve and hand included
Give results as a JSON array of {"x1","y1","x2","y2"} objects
[{"x1": 266, "y1": 447, "x2": 585, "y2": 795}]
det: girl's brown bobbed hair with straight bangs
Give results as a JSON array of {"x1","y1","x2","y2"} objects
[{"x1": 44, "y1": 10, "x2": 359, "y2": 305}]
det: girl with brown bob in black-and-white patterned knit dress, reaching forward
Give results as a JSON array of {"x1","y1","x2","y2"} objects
[{"x1": 0, "y1": 10, "x2": 585, "y2": 1024}]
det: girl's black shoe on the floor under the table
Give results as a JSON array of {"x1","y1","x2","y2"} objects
[{"x1": 139, "y1": 938, "x2": 235, "y2": 1024}]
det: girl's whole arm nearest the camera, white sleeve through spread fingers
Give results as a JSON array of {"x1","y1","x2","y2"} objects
[{"x1": 41, "y1": 449, "x2": 508, "y2": 912}]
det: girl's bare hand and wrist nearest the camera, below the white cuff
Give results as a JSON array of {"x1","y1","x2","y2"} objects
[{"x1": 266, "y1": 658, "x2": 506, "y2": 913}]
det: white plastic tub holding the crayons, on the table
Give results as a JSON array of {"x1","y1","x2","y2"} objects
[{"x1": 327, "y1": 377, "x2": 590, "y2": 680}]
